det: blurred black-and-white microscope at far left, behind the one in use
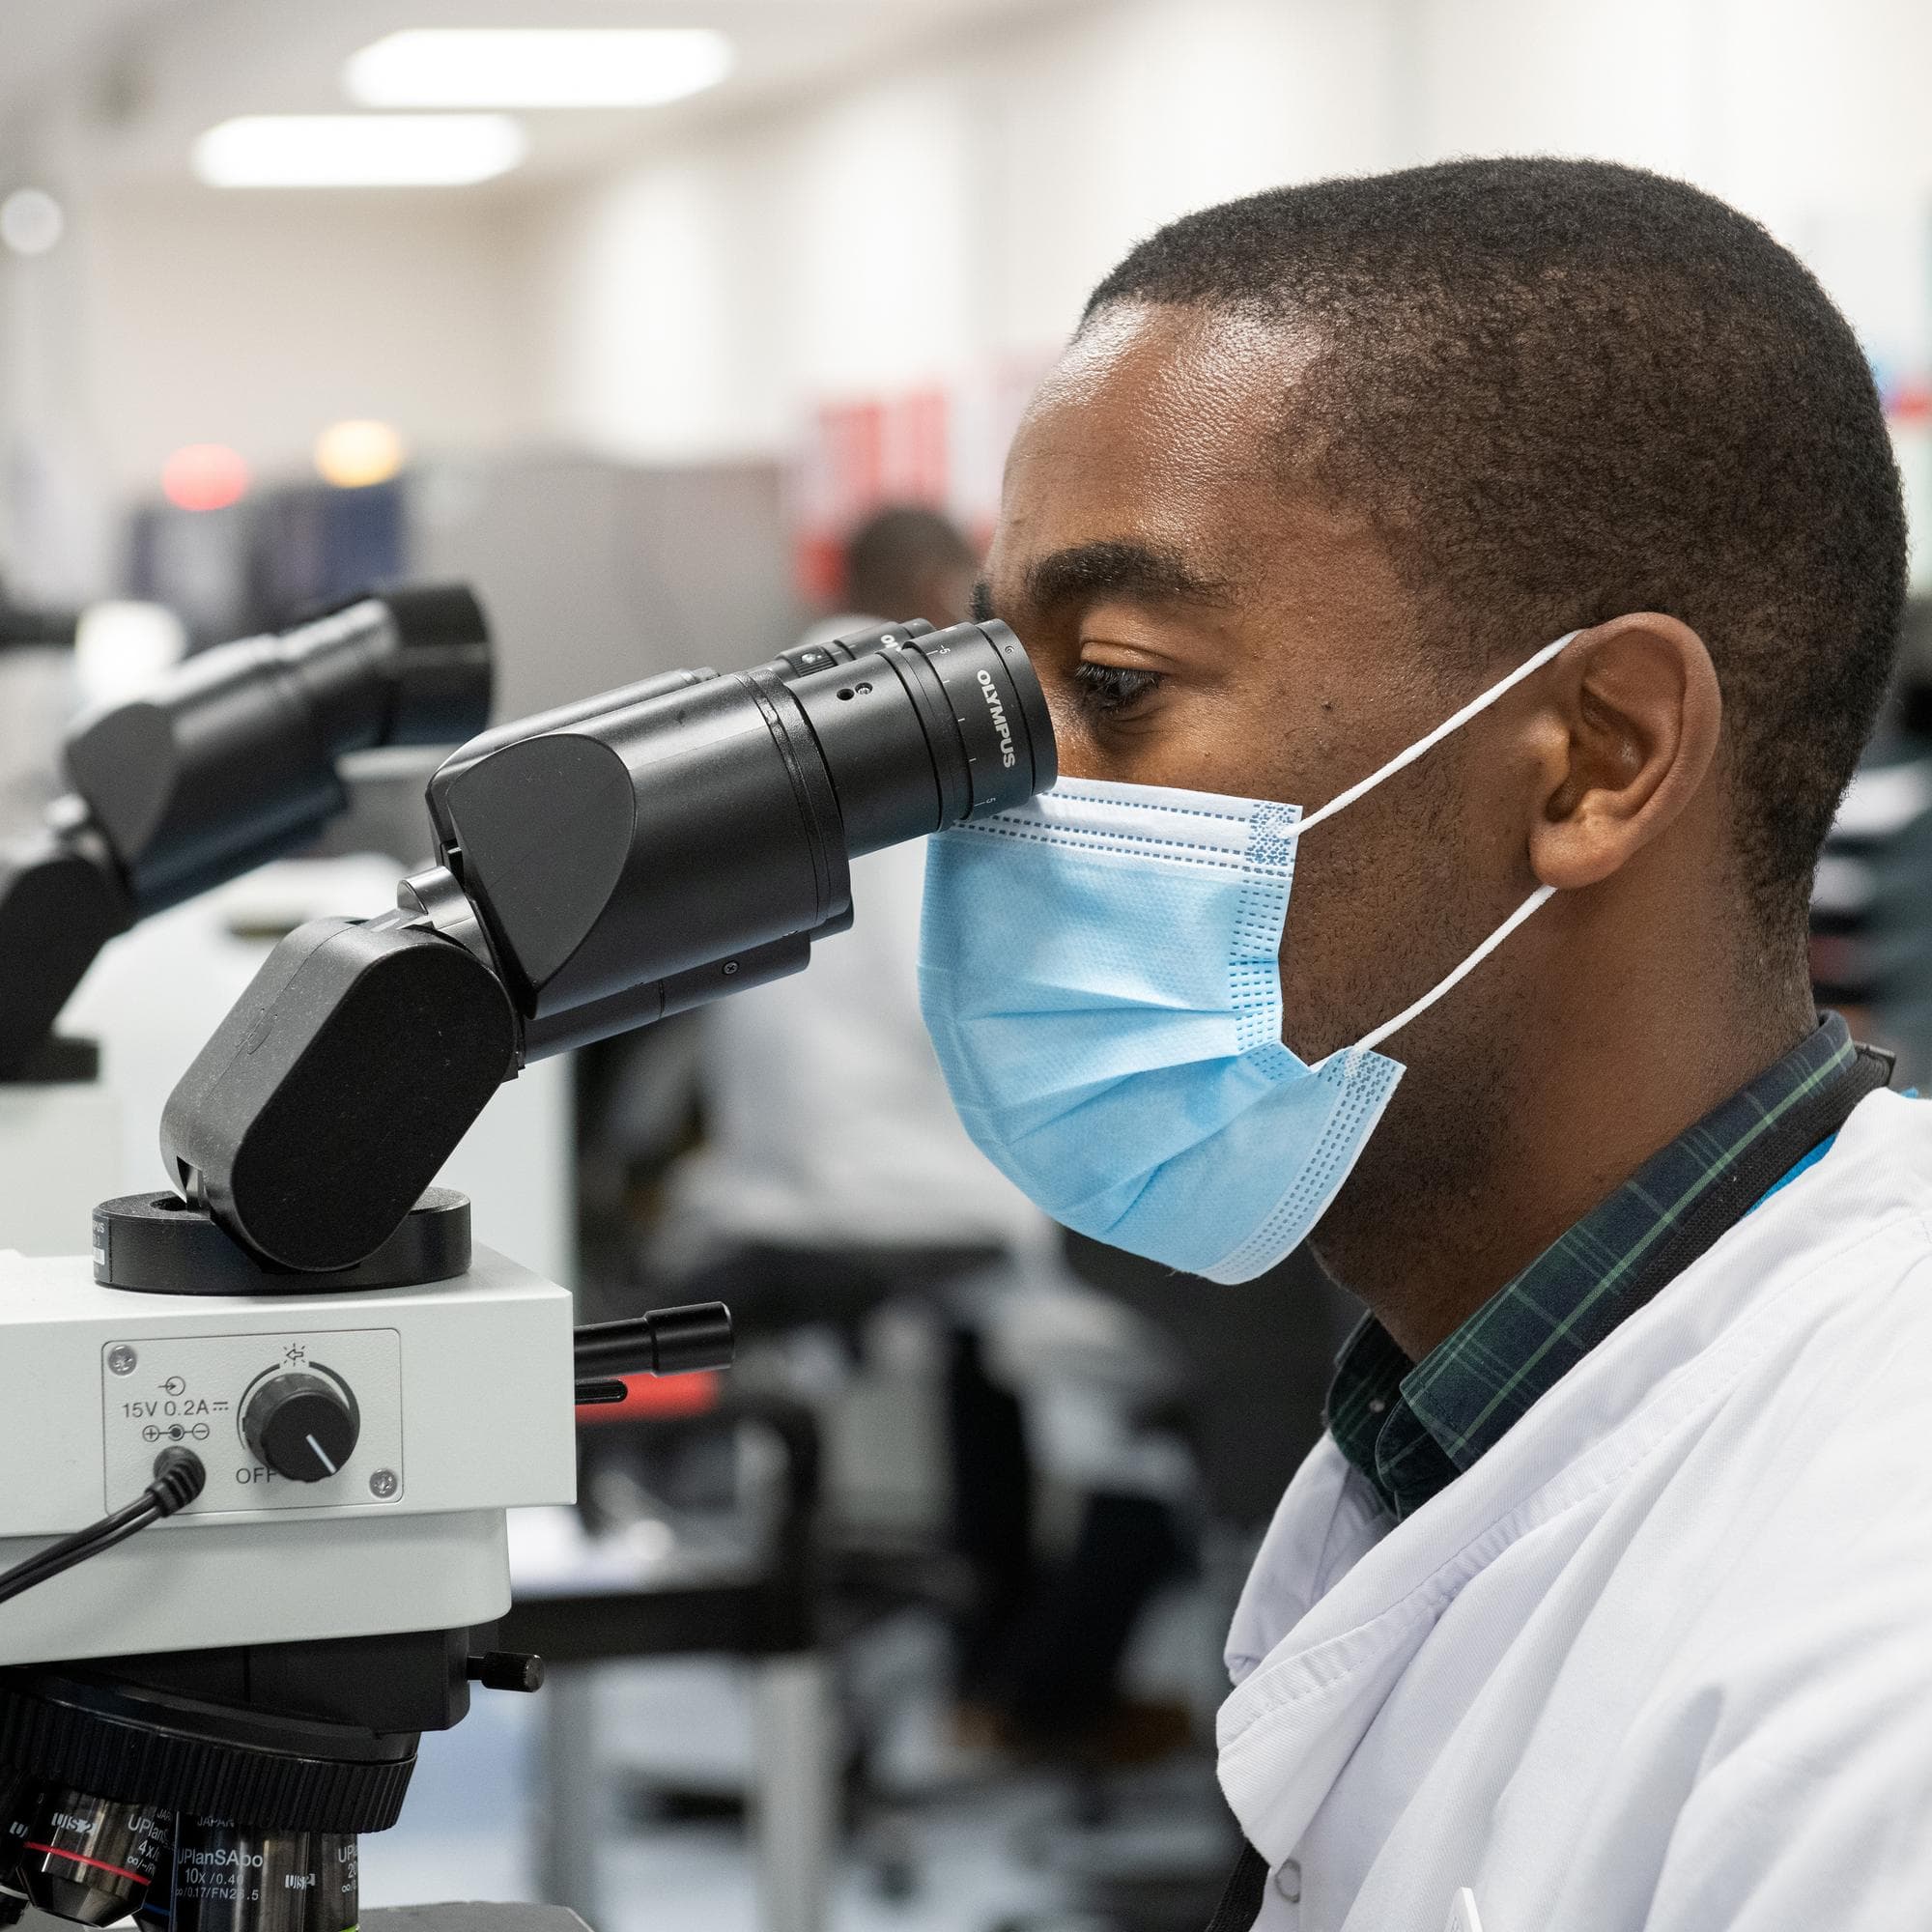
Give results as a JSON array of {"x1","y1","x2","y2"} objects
[{"x1": 0, "y1": 585, "x2": 491, "y2": 1254}]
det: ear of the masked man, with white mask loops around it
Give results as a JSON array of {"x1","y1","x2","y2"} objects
[{"x1": 1530, "y1": 611, "x2": 1723, "y2": 891}]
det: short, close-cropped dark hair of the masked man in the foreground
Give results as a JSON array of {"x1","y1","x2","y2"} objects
[{"x1": 1086, "y1": 158, "x2": 1905, "y2": 941}]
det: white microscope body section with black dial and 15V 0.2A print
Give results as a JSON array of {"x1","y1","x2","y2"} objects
[{"x1": 0, "y1": 1248, "x2": 576, "y2": 1665}]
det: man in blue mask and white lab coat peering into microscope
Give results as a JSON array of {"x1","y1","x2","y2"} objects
[{"x1": 923, "y1": 160, "x2": 1932, "y2": 1932}]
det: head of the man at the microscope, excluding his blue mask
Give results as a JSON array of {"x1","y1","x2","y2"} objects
[{"x1": 989, "y1": 160, "x2": 1905, "y2": 1298}]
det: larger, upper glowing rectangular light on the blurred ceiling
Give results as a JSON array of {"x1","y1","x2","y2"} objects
[{"x1": 342, "y1": 27, "x2": 734, "y2": 108}]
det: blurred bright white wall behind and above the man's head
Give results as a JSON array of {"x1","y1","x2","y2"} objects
[{"x1": 535, "y1": 0, "x2": 1932, "y2": 458}]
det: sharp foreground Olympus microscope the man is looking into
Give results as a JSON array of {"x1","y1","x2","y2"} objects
[{"x1": 0, "y1": 622, "x2": 1055, "y2": 1932}]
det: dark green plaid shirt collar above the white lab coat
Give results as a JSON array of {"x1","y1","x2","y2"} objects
[{"x1": 1327, "y1": 1012, "x2": 1857, "y2": 1517}]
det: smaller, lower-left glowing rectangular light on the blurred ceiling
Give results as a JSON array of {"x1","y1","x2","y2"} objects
[{"x1": 193, "y1": 114, "x2": 529, "y2": 187}]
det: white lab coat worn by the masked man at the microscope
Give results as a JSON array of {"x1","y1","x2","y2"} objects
[{"x1": 1219, "y1": 1094, "x2": 1932, "y2": 1932}]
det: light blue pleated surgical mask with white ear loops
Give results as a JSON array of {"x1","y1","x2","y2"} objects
[{"x1": 920, "y1": 632, "x2": 1577, "y2": 1281}]
